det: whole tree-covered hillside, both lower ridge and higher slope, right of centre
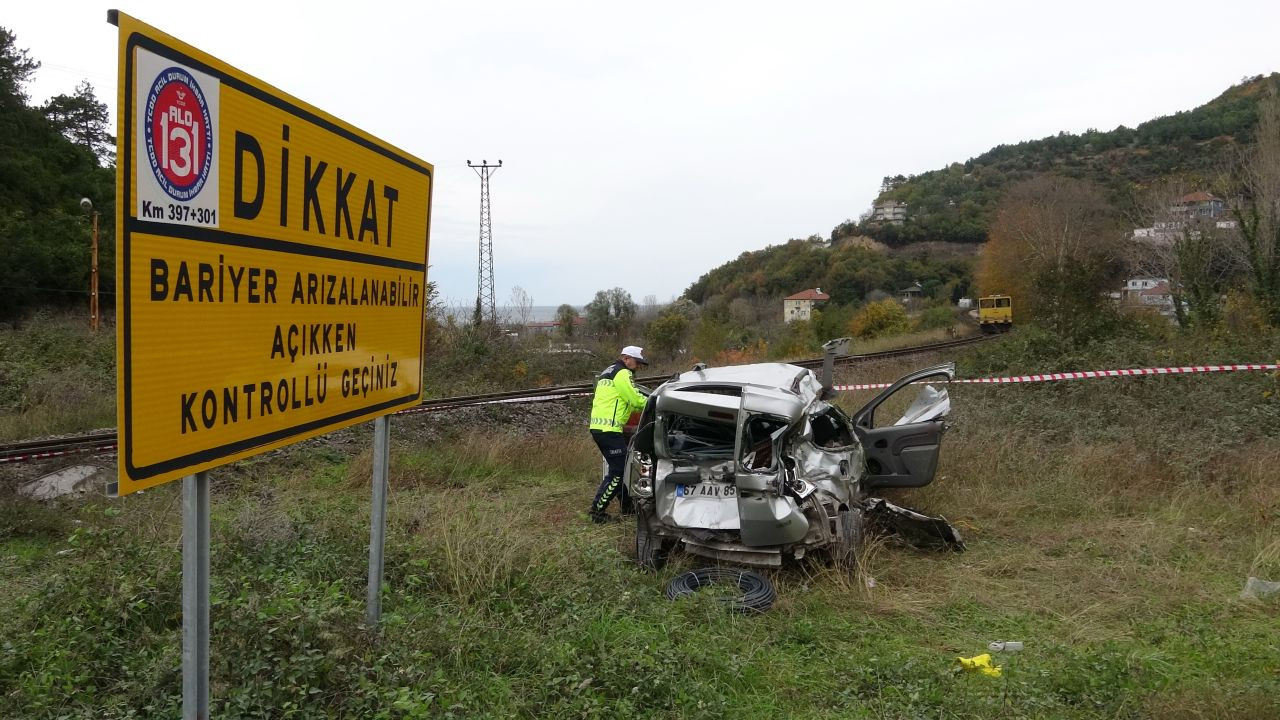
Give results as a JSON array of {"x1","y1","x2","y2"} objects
[{"x1": 685, "y1": 73, "x2": 1280, "y2": 305}]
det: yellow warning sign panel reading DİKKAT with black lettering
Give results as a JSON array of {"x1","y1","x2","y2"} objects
[{"x1": 115, "y1": 13, "x2": 434, "y2": 495}]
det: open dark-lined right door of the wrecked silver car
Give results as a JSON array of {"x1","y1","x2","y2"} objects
[{"x1": 854, "y1": 363, "x2": 955, "y2": 491}]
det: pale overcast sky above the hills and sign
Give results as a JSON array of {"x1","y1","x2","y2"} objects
[{"x1": 0, "y1": 0, "x2": 1280, "y2": 306}]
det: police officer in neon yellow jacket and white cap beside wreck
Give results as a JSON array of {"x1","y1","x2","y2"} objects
[{"x1": 588, "y1": 345, "x2": 649, "y2": 523}]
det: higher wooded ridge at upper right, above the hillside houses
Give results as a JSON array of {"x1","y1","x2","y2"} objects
[{"x1": 832, "y1": 73, "x2": 1280, "y2": 246}]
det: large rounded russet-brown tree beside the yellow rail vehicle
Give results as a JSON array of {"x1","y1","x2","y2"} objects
[{"x1": 977, "y1": 174, "x2": 1123, "y2": 337}]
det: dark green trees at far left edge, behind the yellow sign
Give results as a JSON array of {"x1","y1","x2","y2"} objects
[{"x1": 0, "y1": 27, "x2": 115, "y2": 320}]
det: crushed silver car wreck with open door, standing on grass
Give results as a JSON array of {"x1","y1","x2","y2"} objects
[{"x1": 625, "y1": 363, "x2": 964, "y2": 568}]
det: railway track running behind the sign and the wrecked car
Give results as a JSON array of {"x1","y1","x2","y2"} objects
[{"x1": 0, "y1": 336, "x2": 993, "y2": 465}]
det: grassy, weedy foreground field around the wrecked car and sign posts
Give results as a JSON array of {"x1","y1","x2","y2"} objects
[{"x1": 0, "y1": 333, "x2": 1280, "y2": 719}]
